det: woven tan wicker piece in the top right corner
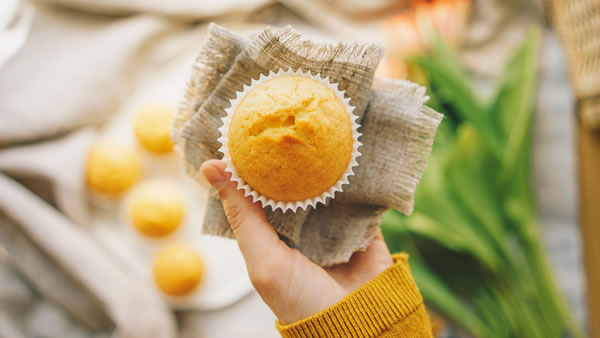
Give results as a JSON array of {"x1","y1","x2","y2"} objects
[{"x1": 550, "y1": 0, "x2": 600, "y2": 128}]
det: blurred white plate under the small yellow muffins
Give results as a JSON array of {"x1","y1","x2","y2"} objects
[{"x1": 92, "y1": 48, "x2": 252, "y2": 310}]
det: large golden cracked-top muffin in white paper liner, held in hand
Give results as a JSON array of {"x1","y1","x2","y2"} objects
[{"x1": 228, "y1": 76, "x2": 353, "y2": 202}]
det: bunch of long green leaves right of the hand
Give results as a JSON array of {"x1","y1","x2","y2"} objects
[{"x1": 396, "y1": 25, "x2": 581, "y2": 337}]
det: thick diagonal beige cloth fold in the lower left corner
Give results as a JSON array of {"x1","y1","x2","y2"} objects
[{"x1": 0, "y1": 175, "x2": 175, "y2": 337}]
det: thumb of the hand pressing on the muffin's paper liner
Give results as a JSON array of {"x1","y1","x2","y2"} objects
[{"x1": 200, "y1": 160, "x2": 287, "y2": 270}]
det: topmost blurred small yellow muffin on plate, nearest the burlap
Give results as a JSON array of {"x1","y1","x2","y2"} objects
[{"x1": 134, "y1": 105, "x2": 175, "y2": 154}]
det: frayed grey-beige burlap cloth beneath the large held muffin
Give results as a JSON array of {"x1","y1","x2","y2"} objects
[{"x1": 172, "y1": 24, "x2": 442, "y2": 266}]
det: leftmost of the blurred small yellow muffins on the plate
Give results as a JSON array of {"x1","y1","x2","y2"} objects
[{"x1": 86, "y1": 141, "x2": 142, "y2": 197}]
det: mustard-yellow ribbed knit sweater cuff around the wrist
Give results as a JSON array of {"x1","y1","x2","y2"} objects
[{"x1": 277, "y1": 254, "x2": 432, "y2": 338}]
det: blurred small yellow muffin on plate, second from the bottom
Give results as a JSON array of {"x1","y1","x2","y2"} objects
[{"x1": 128, "y1": 180, "x2": 185, "y2": 238}]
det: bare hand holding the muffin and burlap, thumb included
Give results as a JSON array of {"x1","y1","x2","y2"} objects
[{"x1": 200, "y1": 160, "x2": 393, "y2": 324}]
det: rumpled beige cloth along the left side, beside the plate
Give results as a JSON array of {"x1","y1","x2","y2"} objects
[{"x1": 0, "y1": 3, "x2": 205, "y2": 338}]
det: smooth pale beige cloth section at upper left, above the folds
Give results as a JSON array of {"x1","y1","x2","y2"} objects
[{"x1": 0, "y1": 5, "x2": 198, "y2": 147}]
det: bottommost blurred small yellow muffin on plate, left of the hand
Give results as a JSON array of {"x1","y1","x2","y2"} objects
[{"x1": 152, "y1": 243, "x2": 204, "y2": 296}]
